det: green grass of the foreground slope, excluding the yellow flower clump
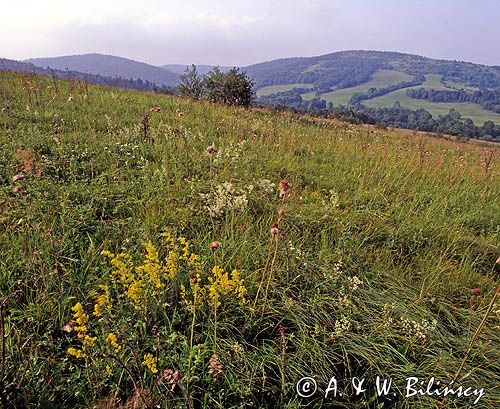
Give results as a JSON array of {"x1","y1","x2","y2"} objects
[{"x1": 0, "y1": 73, "x2": 500, "y2": 408}]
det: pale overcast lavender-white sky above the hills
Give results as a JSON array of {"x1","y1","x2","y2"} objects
[{"x1": 0, "y1": 0, "x2": 500, "y2": 66}]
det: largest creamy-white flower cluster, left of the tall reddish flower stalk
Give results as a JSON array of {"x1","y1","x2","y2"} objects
[{"x1": 200, "y1": 182, "x2": 248, "y2": 217}]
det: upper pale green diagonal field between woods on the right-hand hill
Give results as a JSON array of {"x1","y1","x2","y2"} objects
[{"x1": 302, "y1": 70, "x2": 413, "y2": 105}]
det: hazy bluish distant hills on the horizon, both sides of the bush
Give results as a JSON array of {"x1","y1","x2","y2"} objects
[{"x1": 6, "y1": 51, "x2": 500, "y2": 126}]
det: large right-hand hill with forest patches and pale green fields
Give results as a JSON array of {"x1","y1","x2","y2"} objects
[{"x1": 250, "y1": 51, "x2": 500, "y2": 140}]
